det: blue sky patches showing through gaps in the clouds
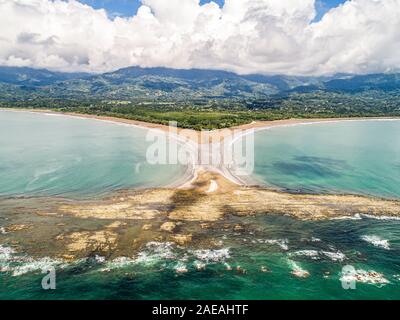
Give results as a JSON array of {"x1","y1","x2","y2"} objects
[{"x1": 80, "y1": 0, "x2": 346, "y2": 21}]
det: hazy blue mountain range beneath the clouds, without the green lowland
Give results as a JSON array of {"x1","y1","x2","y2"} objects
[{"x1": 0, "y1": 67, "x2": 400, "y2": 101}]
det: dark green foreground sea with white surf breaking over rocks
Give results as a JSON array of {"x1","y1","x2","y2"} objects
[{"x1": 0, "y1": 216, "x2": 400, "y2": 299}]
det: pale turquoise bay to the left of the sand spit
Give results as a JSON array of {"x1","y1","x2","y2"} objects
[{"x1": 0, "y1": 111, "x2": 185, "y2": 198}]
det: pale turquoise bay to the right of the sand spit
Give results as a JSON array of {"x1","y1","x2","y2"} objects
[{"x1": 254, "y1": 120, "x2": 400, "y2": 198}]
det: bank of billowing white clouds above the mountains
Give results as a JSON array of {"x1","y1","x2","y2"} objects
[{"x1": 0, "y1": 0, "x2": 400, "y2": 74}]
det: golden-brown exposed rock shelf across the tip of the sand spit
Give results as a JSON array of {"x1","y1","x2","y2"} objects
[{"x1": 48, "y1": 171, "x2": 400, "y2": 224}]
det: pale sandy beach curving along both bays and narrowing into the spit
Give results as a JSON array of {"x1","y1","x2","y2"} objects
[{"x1": 0, "y1": 108, "x2": 400, "y2": 190}]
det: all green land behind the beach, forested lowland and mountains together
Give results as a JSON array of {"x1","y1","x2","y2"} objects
[{"x1": 0, "y1": 67, "x2": 400, "y2": 129}]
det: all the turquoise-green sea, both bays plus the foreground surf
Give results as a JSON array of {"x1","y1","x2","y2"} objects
[{"x1": 0, "y1": 113, "x2": 400, "y2": 299}]
